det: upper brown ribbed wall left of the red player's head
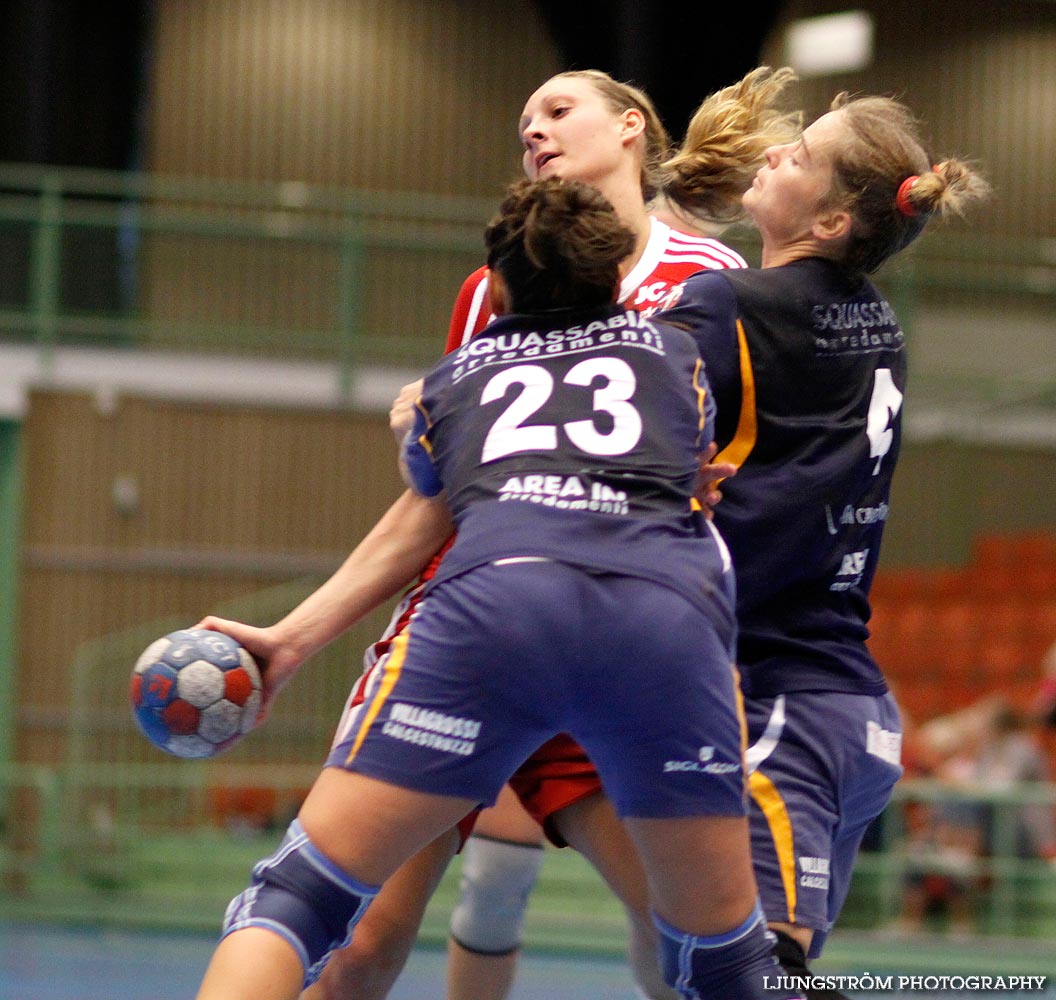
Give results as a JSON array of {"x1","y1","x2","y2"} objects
[{"x1": 138, "y1": 0, "x2": 559, "y2": 363}]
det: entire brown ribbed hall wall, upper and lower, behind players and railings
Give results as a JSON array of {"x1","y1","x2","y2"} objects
[{"x1": 6, "y1": 0, "x2": 1056, "y2": 761}]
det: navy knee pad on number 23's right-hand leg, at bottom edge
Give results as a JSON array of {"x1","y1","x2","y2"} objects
[{"x1": 654, "y1": 907, "x2": 803, "y2": 1000}]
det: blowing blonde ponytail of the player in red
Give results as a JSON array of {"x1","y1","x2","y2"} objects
[{"x1": 660, "y1": 67, "x2": 803, "y2": 223}]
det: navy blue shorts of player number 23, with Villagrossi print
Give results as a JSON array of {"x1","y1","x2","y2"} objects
[{"x1": 326, "y1": 560, "x2": 746, "y2": 817}]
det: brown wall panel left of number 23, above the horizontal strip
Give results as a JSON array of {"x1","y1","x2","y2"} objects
[{"x1": 25, "y1": 393, "x2": 398, "y2": 553}]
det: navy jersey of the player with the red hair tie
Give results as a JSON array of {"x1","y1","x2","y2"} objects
[{"x1": 663, "y1": 258, "x2": 906, "y2": 697}]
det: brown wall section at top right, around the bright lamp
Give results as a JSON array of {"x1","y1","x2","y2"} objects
[{"x1": 765, "y1": 0, "x2": 1056, "y2": 238}]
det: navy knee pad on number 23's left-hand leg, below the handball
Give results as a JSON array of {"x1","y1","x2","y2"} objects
[{"x1": 223, "y1": 819, "x2": 378, "y2": 985}]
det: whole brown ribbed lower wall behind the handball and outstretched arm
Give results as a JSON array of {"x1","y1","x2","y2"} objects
[{"x1": 16, "y1": 392, "x2": 401, "y2": 762}]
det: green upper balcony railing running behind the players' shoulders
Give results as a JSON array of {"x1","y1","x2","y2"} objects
[{"x1": 0, "y1": 165, "x2": 1056, "y2": 409}]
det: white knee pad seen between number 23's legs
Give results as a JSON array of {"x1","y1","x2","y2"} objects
[{"x1": 451, "y1": 836, "x2": 543, "y2": 955}]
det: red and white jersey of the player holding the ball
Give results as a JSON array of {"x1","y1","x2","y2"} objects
[{"x1": 445, "y1": 219, "x2": 748, "y2": 354}]
